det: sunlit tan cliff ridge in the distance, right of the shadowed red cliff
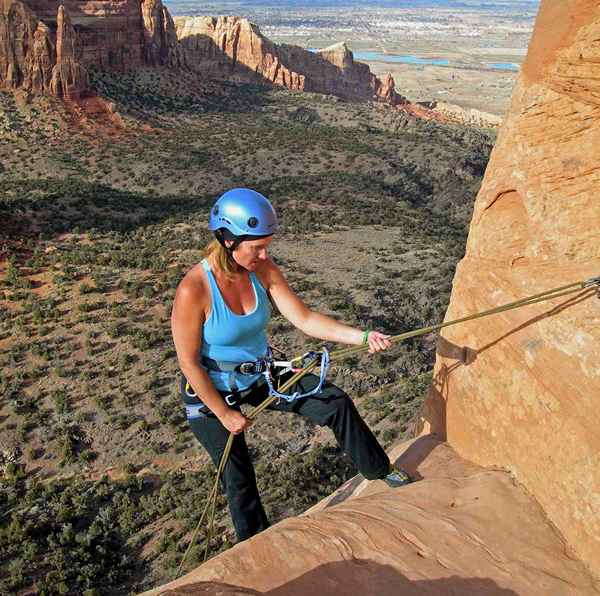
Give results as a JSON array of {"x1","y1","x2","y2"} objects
[{"x1": 175, "y1": 17, "x2": 406, "y2": 105}]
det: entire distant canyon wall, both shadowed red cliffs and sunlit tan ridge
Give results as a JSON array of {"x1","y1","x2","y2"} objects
[{"x1": 0, "y1": 0, "x2": 407, "y2": 105}]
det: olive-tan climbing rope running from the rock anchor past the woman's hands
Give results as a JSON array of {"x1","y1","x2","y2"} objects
[{"x1": 175, "y1": 276, "x2": 600, "y2": 578}]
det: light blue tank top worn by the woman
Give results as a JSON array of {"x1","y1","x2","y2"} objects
[{"x1": 200, "y1": 259, "x2": 271, "y2": 391}]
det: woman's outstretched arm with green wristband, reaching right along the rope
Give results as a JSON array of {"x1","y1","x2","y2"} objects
[{"x1": 261, "y1": 261, "x2": 392, "y2": 352}]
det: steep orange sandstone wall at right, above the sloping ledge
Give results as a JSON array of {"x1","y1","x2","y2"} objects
[{"x1": 422, "y1": 0, "x2": 600, "y2": 574}]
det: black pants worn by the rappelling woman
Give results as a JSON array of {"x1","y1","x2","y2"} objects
[{"x1": 186, "y1": 374, "x2": 390, "y2": 541}]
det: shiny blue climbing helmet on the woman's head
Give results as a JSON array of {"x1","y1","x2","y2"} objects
[{"x1": 208, "y1": 188, "x2": 277, "y2": 250}]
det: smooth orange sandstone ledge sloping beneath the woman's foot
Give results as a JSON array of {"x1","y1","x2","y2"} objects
[{"x1": 143, "y1": 439, "x2": 599, "y2": 596}]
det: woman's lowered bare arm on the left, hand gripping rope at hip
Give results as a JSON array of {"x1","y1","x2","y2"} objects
[{"x1": 171, "y1": 278, "x2": 252, "y2": 434}]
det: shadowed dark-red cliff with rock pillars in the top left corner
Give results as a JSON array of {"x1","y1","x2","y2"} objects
[{"x1": 0, "y1": 0, "x2": 184, "y2": 99}]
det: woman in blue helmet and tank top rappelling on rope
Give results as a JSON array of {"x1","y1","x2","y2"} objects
[{"x1": 171, "y1": 188, "x2": 410, "y2": 540}]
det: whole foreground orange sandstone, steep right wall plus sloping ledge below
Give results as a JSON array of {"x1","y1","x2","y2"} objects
[{"x1": 146, "y1": 0, "x2": 600, "y2": 596}]
